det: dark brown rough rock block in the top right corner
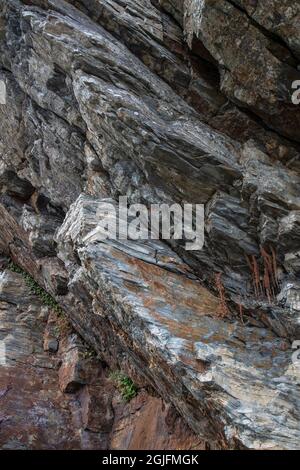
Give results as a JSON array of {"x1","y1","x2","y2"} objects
[{"x1": 185, "y1": 0, "x2": 300, "y2": 141}]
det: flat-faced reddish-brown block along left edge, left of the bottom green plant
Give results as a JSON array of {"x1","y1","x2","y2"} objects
[{"x1": 0, "y1": 271, "x2": 89, "y2": 449}]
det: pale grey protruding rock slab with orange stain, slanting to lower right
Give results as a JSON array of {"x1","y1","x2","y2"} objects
[{"x1": 57, "y1": 198, "x2": 300, "y2": 448}]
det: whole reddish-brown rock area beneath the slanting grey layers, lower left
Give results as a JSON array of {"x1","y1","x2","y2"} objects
[{"x1": 0, "y1": 270, "x2": 205, "y2": 450}]
